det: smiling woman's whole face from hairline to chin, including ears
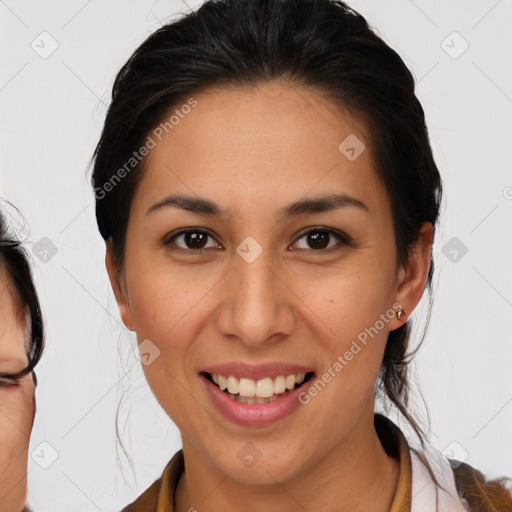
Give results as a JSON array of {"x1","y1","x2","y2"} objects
[{"x1": 107, "y1": 84, "x2": 429, "y2": 483}]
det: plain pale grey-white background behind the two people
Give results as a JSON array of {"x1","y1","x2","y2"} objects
[{"x1": 0, "y1": 0, "x2": 512, "y2": 512}]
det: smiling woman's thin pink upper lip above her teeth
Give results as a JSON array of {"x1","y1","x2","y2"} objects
[{"x1": 199, "y1": 362, "x2": 313, "y2": 380}]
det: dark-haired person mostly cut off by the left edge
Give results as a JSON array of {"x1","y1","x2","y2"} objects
[{"x1": 0, "y1": 206, "x2": 44, "y2": 512}]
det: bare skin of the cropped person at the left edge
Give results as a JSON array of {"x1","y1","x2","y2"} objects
[{"x1": 0, "y1": 267, "x2": 34, "y2": 512}]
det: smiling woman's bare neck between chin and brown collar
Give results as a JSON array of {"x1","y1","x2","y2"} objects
[{"x1": 175, "y1": 411, "x2": 399, "y2": 512}]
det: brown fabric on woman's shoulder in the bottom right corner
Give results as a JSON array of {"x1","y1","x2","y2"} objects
[{"x1": 449, "y1": 459, "x2": 512, "y2": 512}]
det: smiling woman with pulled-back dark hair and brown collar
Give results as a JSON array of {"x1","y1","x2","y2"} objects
[{"x1": 93, "y1": 0, "x2": 512, "y2": 512}]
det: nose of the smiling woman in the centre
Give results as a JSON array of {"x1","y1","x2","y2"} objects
[{"x1": 216, "y1": 251, "x2": 296, "y2": 348}]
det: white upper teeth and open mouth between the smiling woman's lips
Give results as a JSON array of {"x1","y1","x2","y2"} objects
[{"x1": 202, "y1": 372, "x2": 315, "y2": 405}]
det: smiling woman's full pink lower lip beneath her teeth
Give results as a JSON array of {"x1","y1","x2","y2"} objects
[{"x1": 201, "y1": 375, "x2": 311, "y2": 427}]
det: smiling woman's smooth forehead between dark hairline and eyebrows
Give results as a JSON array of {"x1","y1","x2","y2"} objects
[{"x1": 134, "y1": 83, "x2": 383, "y2": 216}]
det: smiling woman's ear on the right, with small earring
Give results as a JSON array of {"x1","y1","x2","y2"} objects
[{"x1": 390, "y1": 222, "x2": 434, "y2": 330}]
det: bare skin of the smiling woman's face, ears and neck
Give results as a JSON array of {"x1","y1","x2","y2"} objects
[{"x1": 106, "y1": 83, "x2": 432, "y2": 512}]
